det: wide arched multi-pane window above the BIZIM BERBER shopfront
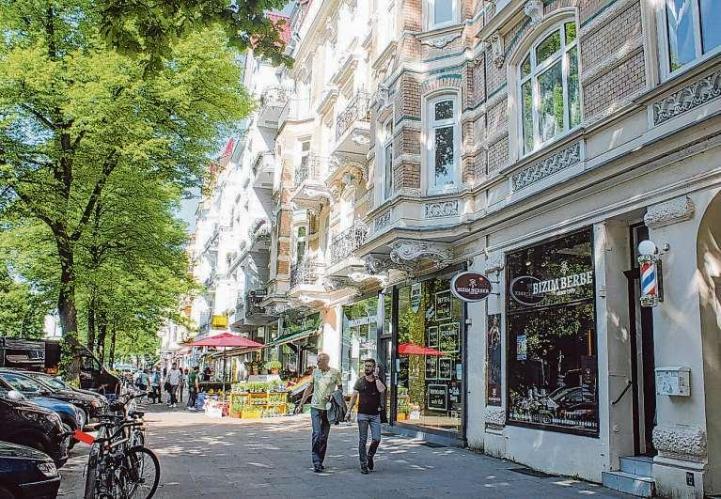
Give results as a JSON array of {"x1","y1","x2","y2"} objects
[{"x1": 519, "y1": 22, "x2": 581, "y2": 154}]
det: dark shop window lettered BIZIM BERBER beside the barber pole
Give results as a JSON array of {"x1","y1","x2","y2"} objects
[{"x1": 506, "y1": 229, "x2": 598, "y2": 435}]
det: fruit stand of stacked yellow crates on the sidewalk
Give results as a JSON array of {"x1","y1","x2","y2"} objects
[{"x1": 229, "y1": 381, "x2": 288, "y2": 419}]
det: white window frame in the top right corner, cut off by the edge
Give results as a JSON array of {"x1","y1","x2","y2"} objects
[{"x1": 655, "y1": 0, "x2": 721, "y2": 81}]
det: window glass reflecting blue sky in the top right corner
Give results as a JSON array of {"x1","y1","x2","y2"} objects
[{"x1": 659, "y1": 0, "x2": 721, "y2": 75}]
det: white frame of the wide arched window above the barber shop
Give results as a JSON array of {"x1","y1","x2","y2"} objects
[{"x1": 514, "y1": 17, "x2": 583, "y2": 158}]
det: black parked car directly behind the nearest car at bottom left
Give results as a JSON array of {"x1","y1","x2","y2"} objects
[{"x1": 0, "y1": 386, "x2": 70, "y2": 467}]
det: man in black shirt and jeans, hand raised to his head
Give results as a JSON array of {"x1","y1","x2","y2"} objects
[{"x1": 347, "y1": 359, "x2": 386, "y2": 475}]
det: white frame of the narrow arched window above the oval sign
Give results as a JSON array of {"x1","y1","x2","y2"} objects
[{"x1": 423, "y1": 91, "x2": 461, "y2": 195}]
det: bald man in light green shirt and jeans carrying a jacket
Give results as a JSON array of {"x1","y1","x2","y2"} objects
[{"x1": 296, "y1": 353, "x2": 341, "y2": 473}]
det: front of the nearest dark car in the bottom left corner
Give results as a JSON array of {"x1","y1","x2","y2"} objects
[{"x1": 0, "y1": 441, "x2": 60, "y2": 499}]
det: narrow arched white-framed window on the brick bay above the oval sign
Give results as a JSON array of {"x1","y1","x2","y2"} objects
[{"x1": 427, "y1": 95, "x2": 459, "y2": 193}]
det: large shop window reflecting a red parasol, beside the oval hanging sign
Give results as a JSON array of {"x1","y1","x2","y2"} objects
[{"x1": 396, "y1": 278, "x2": 464, "y2": 433}]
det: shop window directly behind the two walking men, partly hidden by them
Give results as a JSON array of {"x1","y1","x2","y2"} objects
[{"x1": 341, "y1": 296, "x2": 379, "y2": 393}]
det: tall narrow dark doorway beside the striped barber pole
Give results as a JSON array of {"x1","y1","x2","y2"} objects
[{"x1": 624, "y1": 224, "x2": 656, "y2": 456}]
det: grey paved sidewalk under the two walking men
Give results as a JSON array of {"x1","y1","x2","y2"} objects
[{"x1": 60, "y1": 407, "x2": 630, "y2": 499}]
